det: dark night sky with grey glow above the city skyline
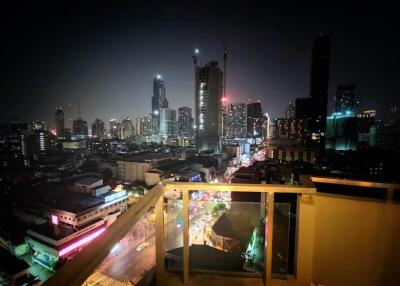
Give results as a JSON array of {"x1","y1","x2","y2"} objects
[{"x1": 0, "y1": 0, "x2": 400, "y2": 128}]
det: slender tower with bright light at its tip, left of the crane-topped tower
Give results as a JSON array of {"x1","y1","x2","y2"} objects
[{"x1": 151, "y1": 74, "x2": 168, "y2": 134}]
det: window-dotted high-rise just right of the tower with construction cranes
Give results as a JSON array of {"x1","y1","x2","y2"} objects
[{"x1": 226, "y1": 103, "x2": 247, "y2": 138}]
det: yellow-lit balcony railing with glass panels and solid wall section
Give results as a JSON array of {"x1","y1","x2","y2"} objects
[{"x1": 44, "y1": 178, "x2": 400, "y2": 286}]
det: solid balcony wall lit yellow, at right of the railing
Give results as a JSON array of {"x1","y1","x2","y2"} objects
[{"x1": 297, "y1": 194, "x2": 400, "y2": 286}]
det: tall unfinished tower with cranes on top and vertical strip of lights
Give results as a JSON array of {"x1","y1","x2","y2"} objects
[{"x1": 194, "y1": 59, "x2": 223, "y2": 151}]
